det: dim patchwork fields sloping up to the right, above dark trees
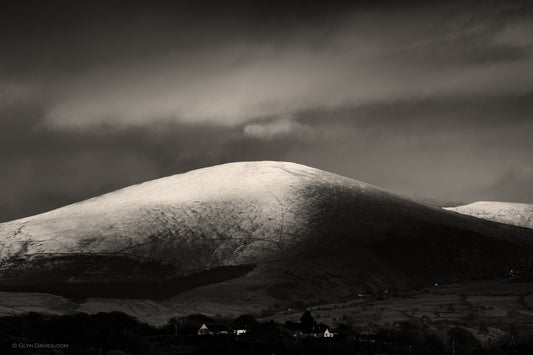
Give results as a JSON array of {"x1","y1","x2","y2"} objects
[{"x1": 260, "y1": 277, "x2": 533, "y2": 344}]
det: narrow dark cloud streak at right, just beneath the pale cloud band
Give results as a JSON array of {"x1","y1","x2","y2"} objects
[{"x1": 295, "y1": 91, "x2": 533, "y2": 134}]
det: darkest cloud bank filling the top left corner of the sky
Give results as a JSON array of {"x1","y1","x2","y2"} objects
[{"x1": 0, "y1": 1, "x2": 356, "y2": 74}]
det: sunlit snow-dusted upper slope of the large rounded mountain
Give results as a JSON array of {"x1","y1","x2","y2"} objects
[{"x1": 0, "y1": 162, "x2": 387, "y2": 281}]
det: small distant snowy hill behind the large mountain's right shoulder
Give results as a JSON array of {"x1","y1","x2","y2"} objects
[{"x1": 445, "y1": 201, "x2": 533, "y2": 229}]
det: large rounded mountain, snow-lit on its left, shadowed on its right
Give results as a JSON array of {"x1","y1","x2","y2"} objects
[{"x1": 0, "y1": 161, "x2": 533, "y2": 320}]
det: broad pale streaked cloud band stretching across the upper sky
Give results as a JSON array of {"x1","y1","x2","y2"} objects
[{"x1": 26, "y1": 0, "x2": 533, "y2": 129}]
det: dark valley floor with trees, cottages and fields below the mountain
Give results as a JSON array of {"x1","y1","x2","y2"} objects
[{"x1": 0, "y1": 277, "x2": 533, "y2": 355}]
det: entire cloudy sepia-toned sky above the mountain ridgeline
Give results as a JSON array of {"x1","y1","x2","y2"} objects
[{"x1": 0, "y1": 0, "x2": 533, "y2": 221}]
